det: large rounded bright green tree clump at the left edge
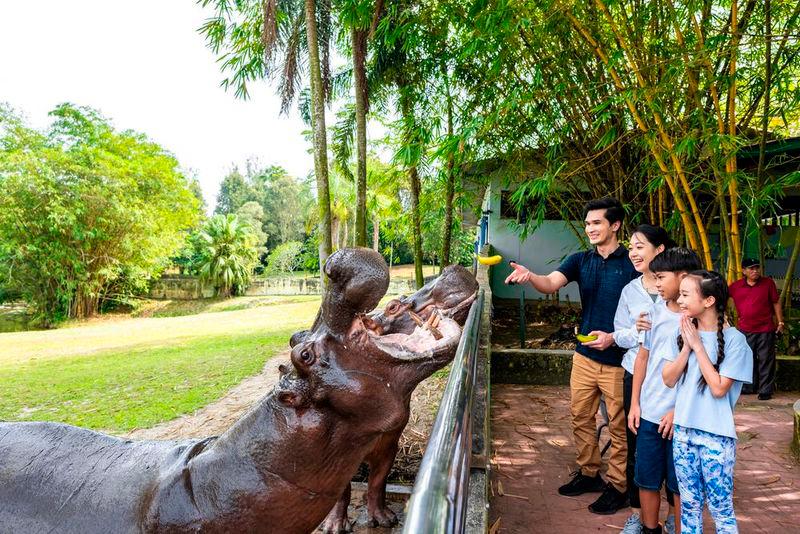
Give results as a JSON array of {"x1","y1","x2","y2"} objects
[{"x1": 0, "y1": 104, "x2": 200, "y2": 325}]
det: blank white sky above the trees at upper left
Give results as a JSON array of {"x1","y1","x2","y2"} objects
[{"x1": 0, "y1": 0, "x2": 322, "y2": 214}]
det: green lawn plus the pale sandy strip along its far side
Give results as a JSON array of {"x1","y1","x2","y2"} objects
[{"x1": 0, "y1": 297, "x2": 319, "y2": 432}]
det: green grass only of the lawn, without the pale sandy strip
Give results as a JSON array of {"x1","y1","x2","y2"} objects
[{"x1": 0, "y1": 329, "x2": 294, "y2": 432}]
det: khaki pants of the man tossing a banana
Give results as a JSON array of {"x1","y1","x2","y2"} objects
[{"x1": 569, "y1": 352, "x2": 628, "y2": 493}]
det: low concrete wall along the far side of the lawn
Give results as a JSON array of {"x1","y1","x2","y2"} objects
[{"x1": 149, "y1": 275, "x2": 424, "y2": 300}]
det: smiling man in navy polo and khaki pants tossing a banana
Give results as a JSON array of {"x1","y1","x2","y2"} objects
[{"x1": 506, "y1": 197, "x2": 639, "y2": 514}]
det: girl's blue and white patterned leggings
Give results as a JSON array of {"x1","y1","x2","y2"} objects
[{"x1": 672, "y1": 425, "x2": 739, "y2": 534}]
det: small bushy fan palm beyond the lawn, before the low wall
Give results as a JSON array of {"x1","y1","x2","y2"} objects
[{"x1": 200, "y1": 214, "x2": 258, "y2": 298}]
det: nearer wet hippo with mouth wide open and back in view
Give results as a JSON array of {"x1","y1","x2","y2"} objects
[{"x1": 0, "y1": 249, "x2": 476, "y2": 534}]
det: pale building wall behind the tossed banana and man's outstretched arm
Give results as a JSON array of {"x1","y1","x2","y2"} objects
[{"x1": 484, "y1": 178, "x2": 580, "y2": 302}]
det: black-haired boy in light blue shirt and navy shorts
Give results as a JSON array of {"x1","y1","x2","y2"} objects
[{"x1": 628, "y1": 248, "x2": 700, "y2": 534}]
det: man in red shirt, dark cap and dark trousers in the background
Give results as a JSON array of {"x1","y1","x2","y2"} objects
[{"x1": 729, "y1": 258, "x2": 783, "y2": 400}]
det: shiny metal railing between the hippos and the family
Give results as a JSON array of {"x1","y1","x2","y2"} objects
[{"x1": 403, "y1": 289, "x2": 484, "y2": 534}]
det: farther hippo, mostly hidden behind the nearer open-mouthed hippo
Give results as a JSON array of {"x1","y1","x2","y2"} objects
[{"x1": 314, "y1": 265, "x2": 478, "y2": 533}]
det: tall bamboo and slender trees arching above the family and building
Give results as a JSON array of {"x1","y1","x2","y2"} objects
[{"x1": 201, "y1": 0, "x2": 800, "y2": 294}]
